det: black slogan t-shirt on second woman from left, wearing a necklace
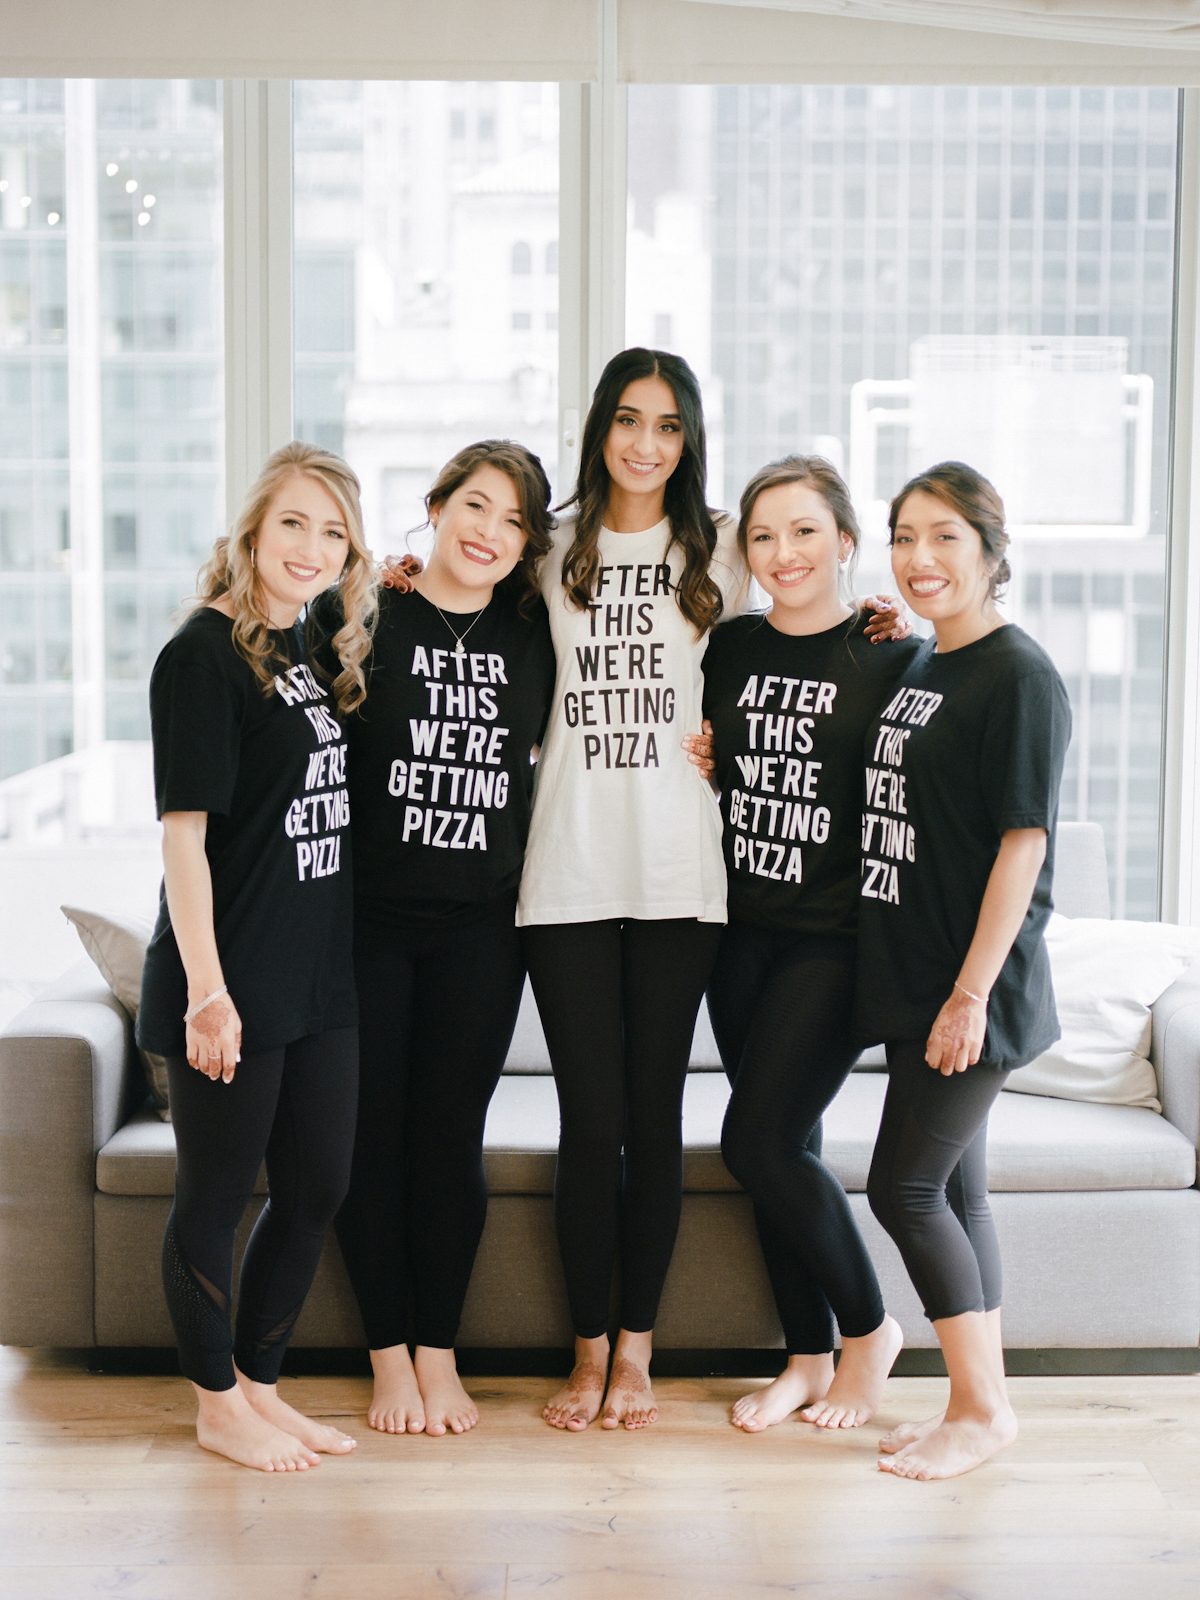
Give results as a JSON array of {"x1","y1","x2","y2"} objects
[{"x1": 317, "y1": 589, "x2": 554, "y2": 925}]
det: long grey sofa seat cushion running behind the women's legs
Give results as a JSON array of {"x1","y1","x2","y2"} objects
[{"x1": 96, "y1": 1072, "x2": 1195, "y2": 1195}]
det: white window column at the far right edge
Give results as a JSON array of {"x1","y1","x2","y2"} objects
[{"x1": 1162, "y1": 90, "x2": 1200, "y2": 926}]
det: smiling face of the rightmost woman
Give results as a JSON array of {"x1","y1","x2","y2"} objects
[{"x1": 891, "y1": 490, "x2": 995, "y2": 627}]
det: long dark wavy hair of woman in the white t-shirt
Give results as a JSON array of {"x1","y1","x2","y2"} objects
[{"x1": 560, "y1": 347, "x2": 722, "y2": 635}]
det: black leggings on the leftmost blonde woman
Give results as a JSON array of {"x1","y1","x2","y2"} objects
[{"x1": 163, "y1": 1027, "x2": 358, "y2": 1389}]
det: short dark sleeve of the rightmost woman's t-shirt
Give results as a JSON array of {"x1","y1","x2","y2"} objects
[{"x1": 979, "y1": 667, "x2": 1070, "y2": 834}]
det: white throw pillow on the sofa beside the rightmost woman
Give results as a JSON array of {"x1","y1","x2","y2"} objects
[{"x1": 1005, "y1": 914, "x2": 1200, "y2": 1112}]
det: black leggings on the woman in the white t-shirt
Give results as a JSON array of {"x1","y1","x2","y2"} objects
[{"x1": 522, "y1": 917, "x2": 722, "y2": 1339}]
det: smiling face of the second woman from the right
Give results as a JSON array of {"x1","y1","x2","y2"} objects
[{"x1": 746, "y1": 483, "x2": 854, "y2": 627}]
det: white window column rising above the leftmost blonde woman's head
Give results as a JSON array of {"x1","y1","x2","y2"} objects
[{"x1": 224, "y1": 78, "x2": 293, "y2": 520}]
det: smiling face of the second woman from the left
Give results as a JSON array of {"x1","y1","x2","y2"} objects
[{"x1": 429, "y1": 466, "x2": 525, "y2": 610}]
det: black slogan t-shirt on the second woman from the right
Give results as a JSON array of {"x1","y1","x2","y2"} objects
[{"x1": 704, "y1": 614, "x2": 918, "y2": 934}]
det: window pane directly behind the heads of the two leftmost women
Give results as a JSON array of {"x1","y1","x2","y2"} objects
[{"x1": 294, "y1": 82, "x2": 558, "y2": 552}]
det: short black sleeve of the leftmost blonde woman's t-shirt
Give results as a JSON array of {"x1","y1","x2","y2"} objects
[{"x1": 150, "y1": 635, "x2": 245, "y2": 816}]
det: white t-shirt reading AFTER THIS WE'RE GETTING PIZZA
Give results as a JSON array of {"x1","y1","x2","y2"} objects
[{"x1": 517, "y1": 518, "x2": 749, "y2": 926}]
